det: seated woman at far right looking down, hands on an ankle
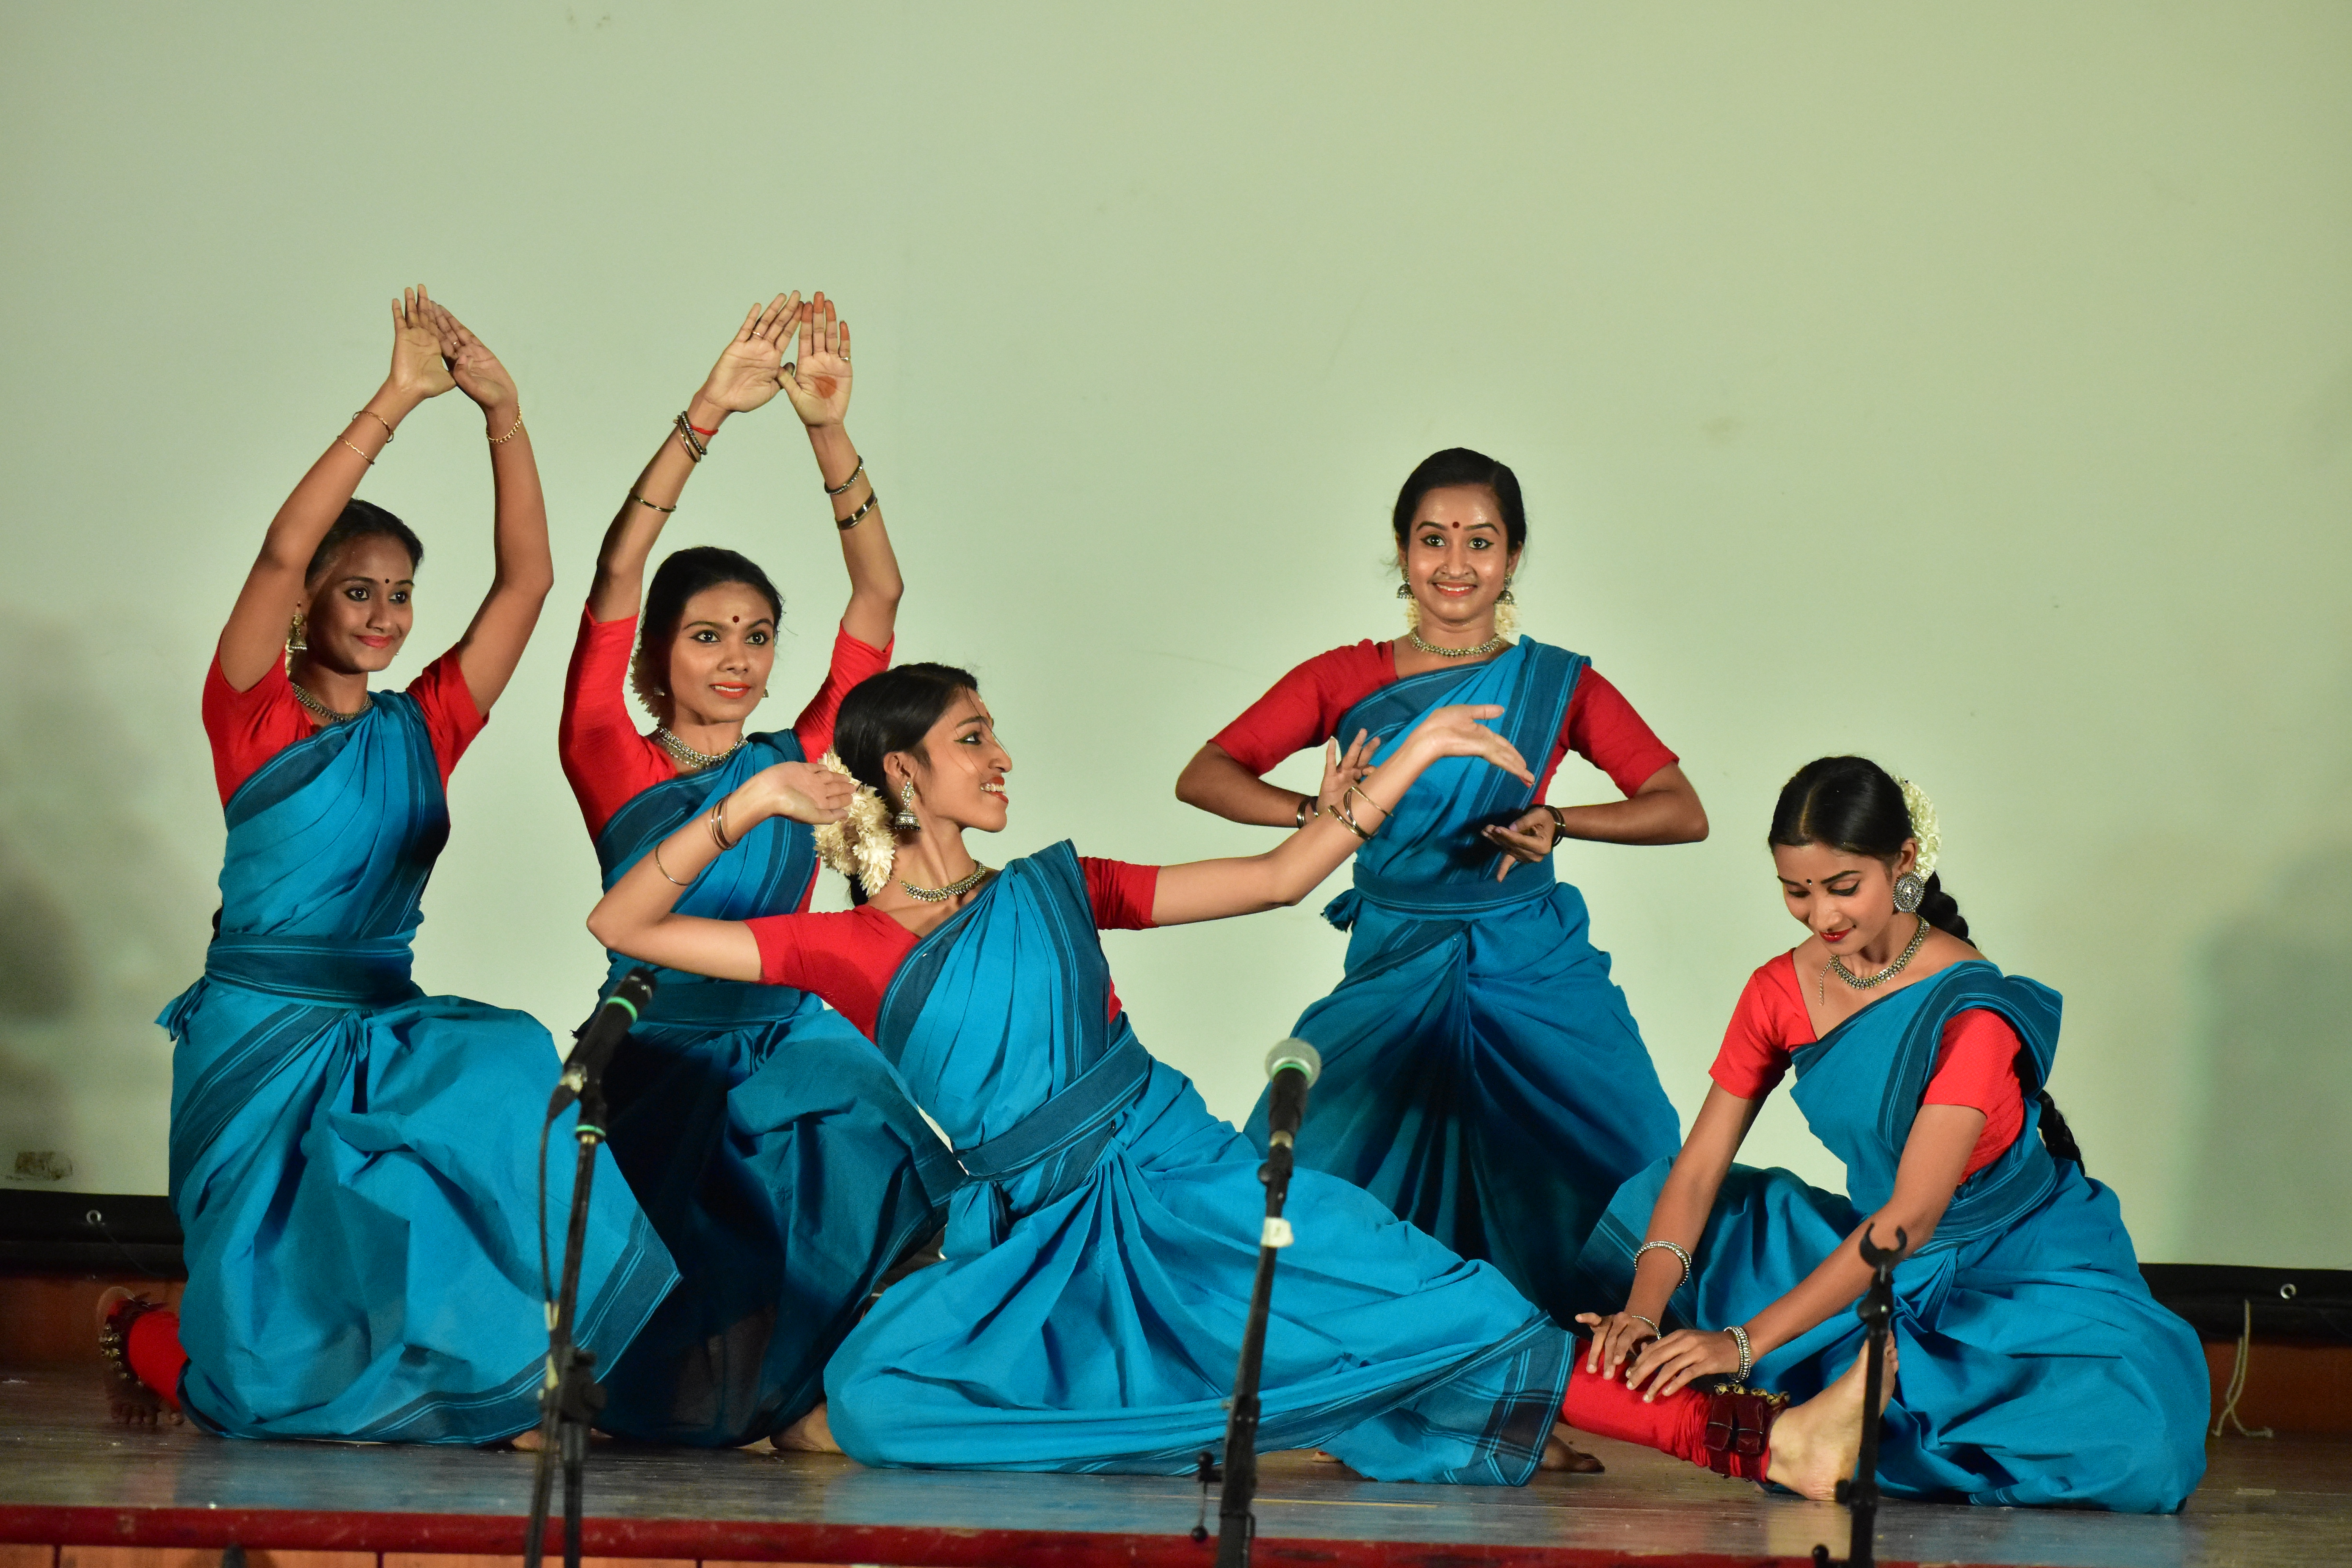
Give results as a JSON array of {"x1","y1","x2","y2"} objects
[{"x1": 1581, "y1": 757, "x2": 2209, "y2": 1512}]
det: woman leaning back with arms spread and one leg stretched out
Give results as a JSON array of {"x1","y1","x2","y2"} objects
[{"x1": 590, "y1": 665, "x2": 1891, "y2": 1495}]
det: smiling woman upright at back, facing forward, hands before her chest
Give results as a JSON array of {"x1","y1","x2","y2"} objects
[{"x1": 1176, "y1": 446, "x2": 1708, "y2": 1323}]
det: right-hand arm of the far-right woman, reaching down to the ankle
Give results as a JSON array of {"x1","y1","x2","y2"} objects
[{"x1": 1625, "y1": 1105, "x2": 1985, "y2": 1399}]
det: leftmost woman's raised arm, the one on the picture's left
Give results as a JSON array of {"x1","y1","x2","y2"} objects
[{"x1": 221, "y1": 287, "x2": 456, "y2": 691}]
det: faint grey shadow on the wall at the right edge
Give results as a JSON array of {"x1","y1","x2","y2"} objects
[{"x1": 2187, "y1": 849, "x2": 2352, "y2": 1269}]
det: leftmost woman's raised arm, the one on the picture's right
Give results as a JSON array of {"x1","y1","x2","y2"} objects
[{"x1": 433, "y1": 306, "x2": 555, "y2": 712}]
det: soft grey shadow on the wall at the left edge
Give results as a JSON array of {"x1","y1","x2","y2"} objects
[{"x1": 0, "y1": 618, "x2": 212, "y2": 1192}]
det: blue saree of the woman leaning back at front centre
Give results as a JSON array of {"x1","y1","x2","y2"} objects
[{"x1": 826, "y1": 844, "x2": 1569, "y2": 1483}]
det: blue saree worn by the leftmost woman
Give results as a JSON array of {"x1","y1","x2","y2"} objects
[{"x1": 158, "y1": 691, "x2": 675, "y2": 1443}]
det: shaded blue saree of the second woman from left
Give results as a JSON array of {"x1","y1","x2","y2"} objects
[{"x1": 597, "y1": 731, "x2": 962, "y2": 1446}]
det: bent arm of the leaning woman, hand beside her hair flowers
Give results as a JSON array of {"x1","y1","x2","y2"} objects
[{"x1": 588, "y1": 762, "x2": 856, "y2": 980}]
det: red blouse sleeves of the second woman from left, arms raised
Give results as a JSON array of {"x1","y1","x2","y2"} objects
[{"x1": 555, "y1": 609, "x2": 889, "y2": 839}]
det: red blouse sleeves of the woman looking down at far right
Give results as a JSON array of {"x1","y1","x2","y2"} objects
[{"x1": 1708, "y1": 952, "x2": 2025, "y2": 1180}]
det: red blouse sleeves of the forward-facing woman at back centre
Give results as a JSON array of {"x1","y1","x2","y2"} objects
[{"x1": 1214, "y1": 642, "x2": 1677, "y2": 799}]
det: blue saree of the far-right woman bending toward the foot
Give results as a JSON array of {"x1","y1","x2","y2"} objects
[{"x1": 1578, "y1": 962, "x2": 2209, "y2": 1512}]
